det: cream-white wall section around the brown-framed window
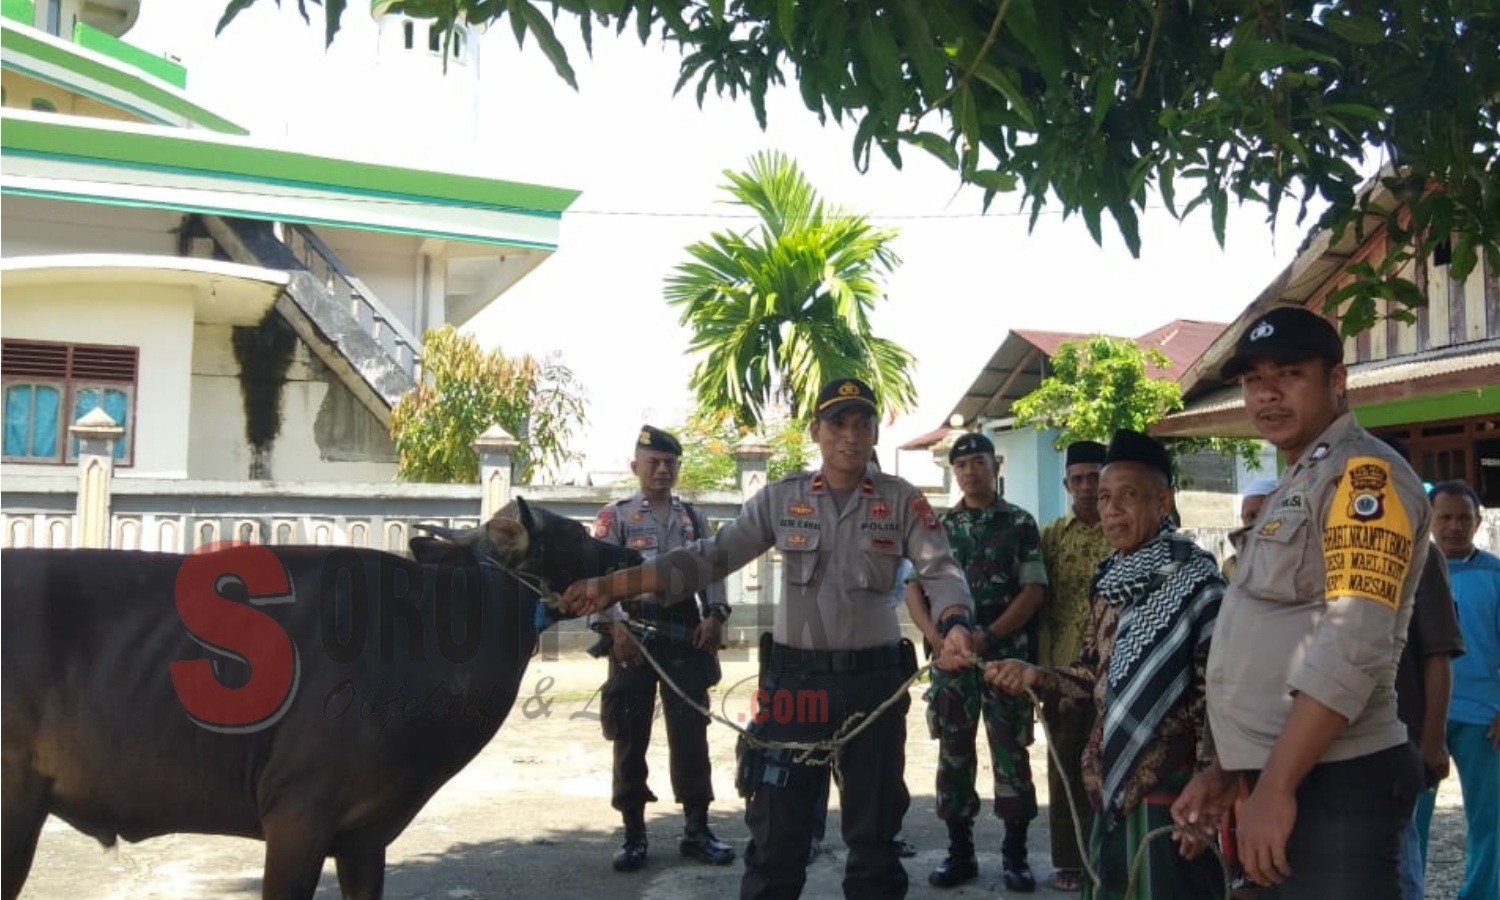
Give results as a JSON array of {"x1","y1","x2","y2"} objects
[{"x1": 5, "y1": 282, "x2": 194, "y2": 479}]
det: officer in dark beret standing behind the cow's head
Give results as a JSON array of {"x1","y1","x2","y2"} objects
[{"x1": 591, "y1": 425, "x2": 735, "y2": 872}]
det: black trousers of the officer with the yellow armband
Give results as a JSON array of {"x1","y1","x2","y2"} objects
[{"x1": 1256, "y1": 743, "x2": 1422, "y2": 900}]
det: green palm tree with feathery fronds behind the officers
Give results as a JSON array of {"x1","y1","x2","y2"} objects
[{"x1": 666, "y1": 153, "x2": 917, "y2": 428}]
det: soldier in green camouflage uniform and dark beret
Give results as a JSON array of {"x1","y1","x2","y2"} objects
[{"x1": 908, "y1": 434, "x2": 1047, "y2": 893}]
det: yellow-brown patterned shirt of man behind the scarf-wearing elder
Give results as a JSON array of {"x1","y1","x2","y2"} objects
[{"x1": 1037, "y1": 510, "x2": 1110, "y2": 666}]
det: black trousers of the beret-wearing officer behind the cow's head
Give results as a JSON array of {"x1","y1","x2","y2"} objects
[{"x1": 600, "y1": 641, "x2": 719, "y2": 812}]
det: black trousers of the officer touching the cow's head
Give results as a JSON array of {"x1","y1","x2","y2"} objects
[{"x1": 740, "y1": 654, "x2": 911, "y2": 900}]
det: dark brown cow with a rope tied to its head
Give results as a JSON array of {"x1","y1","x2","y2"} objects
[{"x1": 0, "y1": 501, "x2": 639, "y2": 900}]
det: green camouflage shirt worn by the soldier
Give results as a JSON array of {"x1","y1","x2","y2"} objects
[{"x1": 942, "y1": 497, "x2": 1047, "y2": 662}]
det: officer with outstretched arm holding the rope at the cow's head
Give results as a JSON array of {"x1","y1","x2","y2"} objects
[{"x1": 566, "y1": 378, "x2": 974, "y2": 900}]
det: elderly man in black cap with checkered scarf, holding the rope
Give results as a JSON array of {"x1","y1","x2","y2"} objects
[{"x1": 986, "y1": 429, "x2": 1224, "y2": 900}]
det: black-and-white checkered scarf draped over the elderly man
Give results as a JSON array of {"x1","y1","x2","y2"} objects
[{"x1": 1094, "y1": 521, "x2": 1224, "y2": 810}]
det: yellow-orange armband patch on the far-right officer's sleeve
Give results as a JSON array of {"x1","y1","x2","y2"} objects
[{"x1": 1323, "y1": 456, "x2": 1412, "y2": 609}]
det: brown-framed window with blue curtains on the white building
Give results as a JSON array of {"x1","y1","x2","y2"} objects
[{"x1": 0, "y1": 339, "x2": 140, "y2": 465}]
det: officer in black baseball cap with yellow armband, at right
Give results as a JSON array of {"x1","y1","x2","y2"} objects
[{"x1": 1173, "y1": 306, "x2": 1431, "y2": 900}]
